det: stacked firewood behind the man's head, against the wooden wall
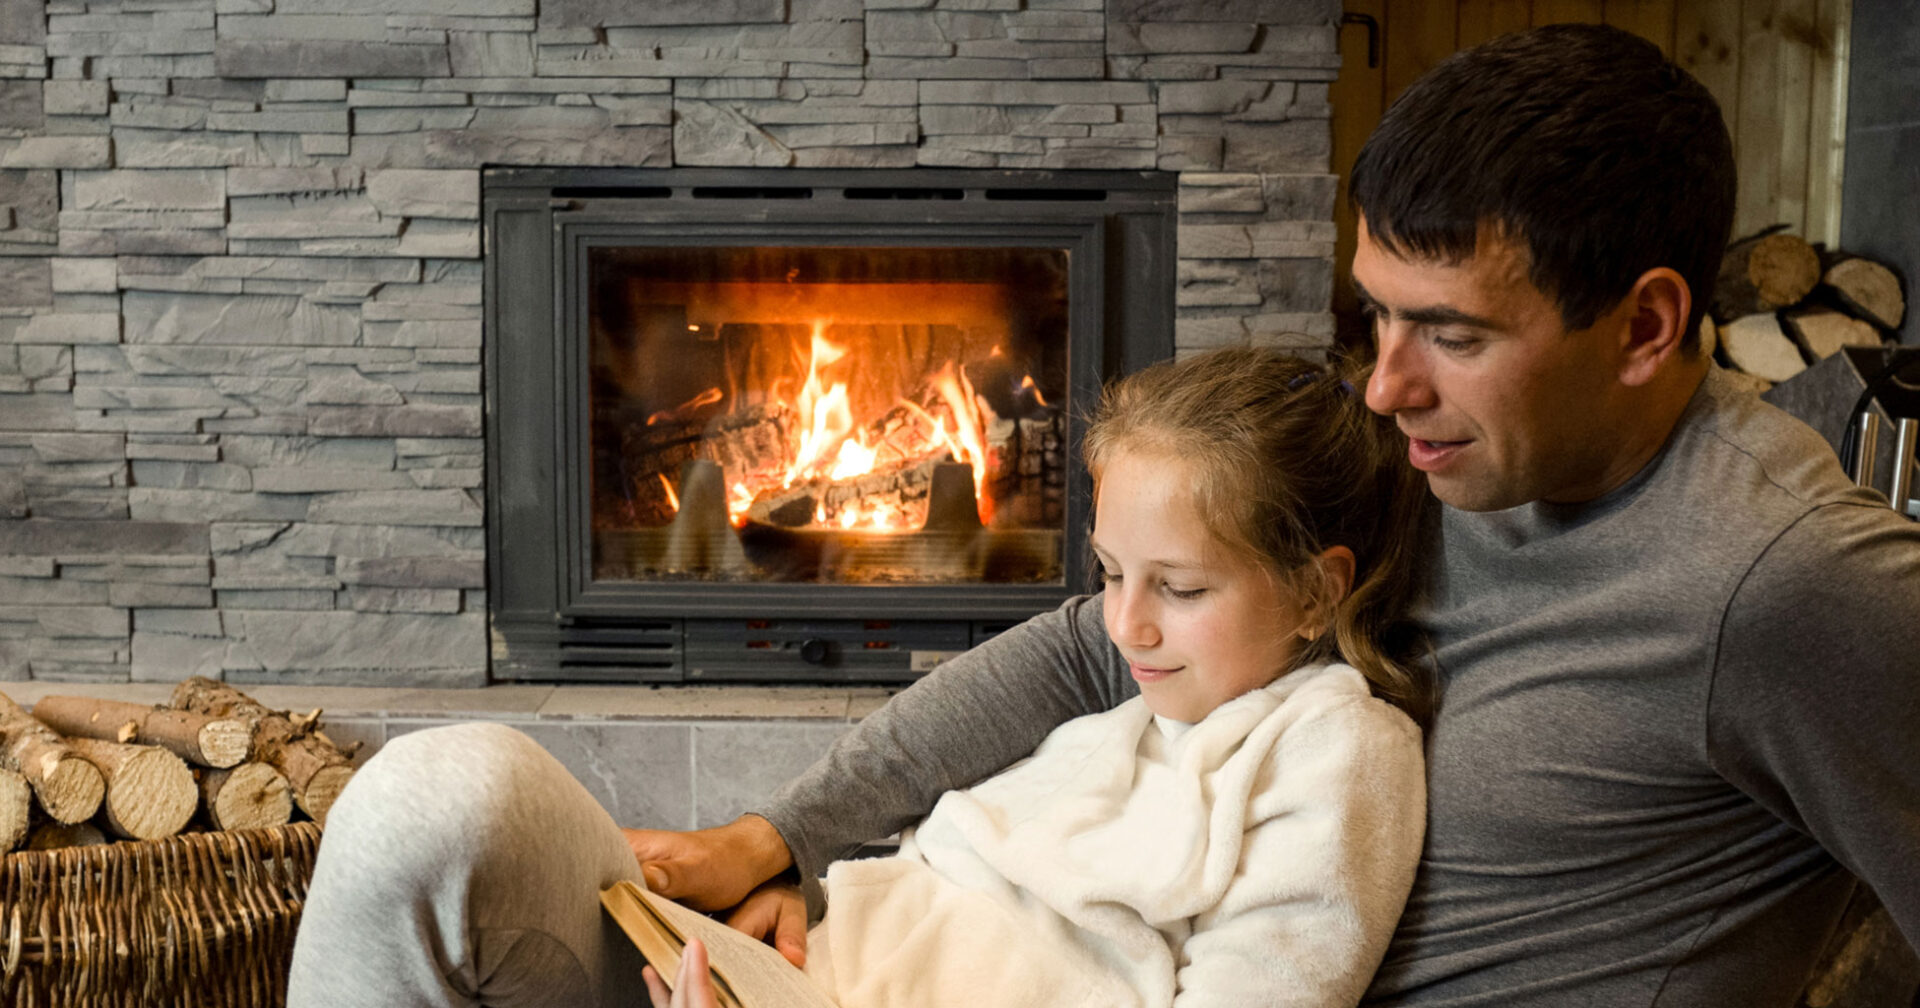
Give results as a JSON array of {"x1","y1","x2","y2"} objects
[{"x1": 1701, "y1": 225, "x2": 1907, "y2": 390}]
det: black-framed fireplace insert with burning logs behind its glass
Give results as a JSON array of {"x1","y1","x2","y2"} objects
[{"x1": 484, "y1": 169, "x2": 1175, "y2": 682}]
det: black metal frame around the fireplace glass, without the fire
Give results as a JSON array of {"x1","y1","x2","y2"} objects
[{"x1": 484, "y1": 169, "x2": 1175, "y2": 682}]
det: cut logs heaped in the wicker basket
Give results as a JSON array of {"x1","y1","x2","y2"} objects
[{"x1": 0, "y1": 676, "x2": 353, "y2": 852}]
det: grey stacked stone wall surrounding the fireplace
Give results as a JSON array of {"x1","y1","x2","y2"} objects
[{"x1": 0, "y1": 0, "x2": 1340, "y2": 684}]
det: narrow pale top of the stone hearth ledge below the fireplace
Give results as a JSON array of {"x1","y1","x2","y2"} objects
[{"x1": 0, "y1": 680, "x2": 893, "y2": 722}]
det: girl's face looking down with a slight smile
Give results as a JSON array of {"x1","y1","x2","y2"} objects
[{"x1": 1092, "y1": 449, "x2": 1308, "y2": 722}]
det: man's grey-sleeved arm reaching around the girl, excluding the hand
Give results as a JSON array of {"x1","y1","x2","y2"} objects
[{"x1": 755, "y1": 595, "x2": 1139, "y2": 877}]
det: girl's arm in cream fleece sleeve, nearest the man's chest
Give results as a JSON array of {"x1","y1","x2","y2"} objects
[{"x1": 1173, "y1": 697, "x2": 1427, "y2": 1008}]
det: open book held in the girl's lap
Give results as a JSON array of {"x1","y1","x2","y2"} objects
[{"x1": 601, "y1": 881, "x2": 835, "y2": 1008}]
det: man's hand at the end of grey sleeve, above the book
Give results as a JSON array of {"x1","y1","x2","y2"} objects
[{"x1": 622, "y1": 816, "x2": 787, "y2": 910}]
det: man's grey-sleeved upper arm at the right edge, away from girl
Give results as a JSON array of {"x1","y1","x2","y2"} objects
[{"x1": 1709, "y1": 505, "x2": 1920, "y2": 947}]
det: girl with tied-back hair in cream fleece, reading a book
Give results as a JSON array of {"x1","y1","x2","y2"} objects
[{"x1": 647, "y1": 349, "x2": 1428, "y2": 1008}]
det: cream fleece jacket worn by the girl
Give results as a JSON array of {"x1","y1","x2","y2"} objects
[{"x1": 808, "y1": 664, "x2": 1425, "y2": 1008}]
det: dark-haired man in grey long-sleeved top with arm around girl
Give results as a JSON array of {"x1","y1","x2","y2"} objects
[{"x1": 630, "y1": 25, "x2": 1920, "y2": 1006}]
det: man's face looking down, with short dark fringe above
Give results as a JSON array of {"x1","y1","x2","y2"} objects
[{"x1": 1354, "y1": 221, "x2": 1632, "y2": 511}]
